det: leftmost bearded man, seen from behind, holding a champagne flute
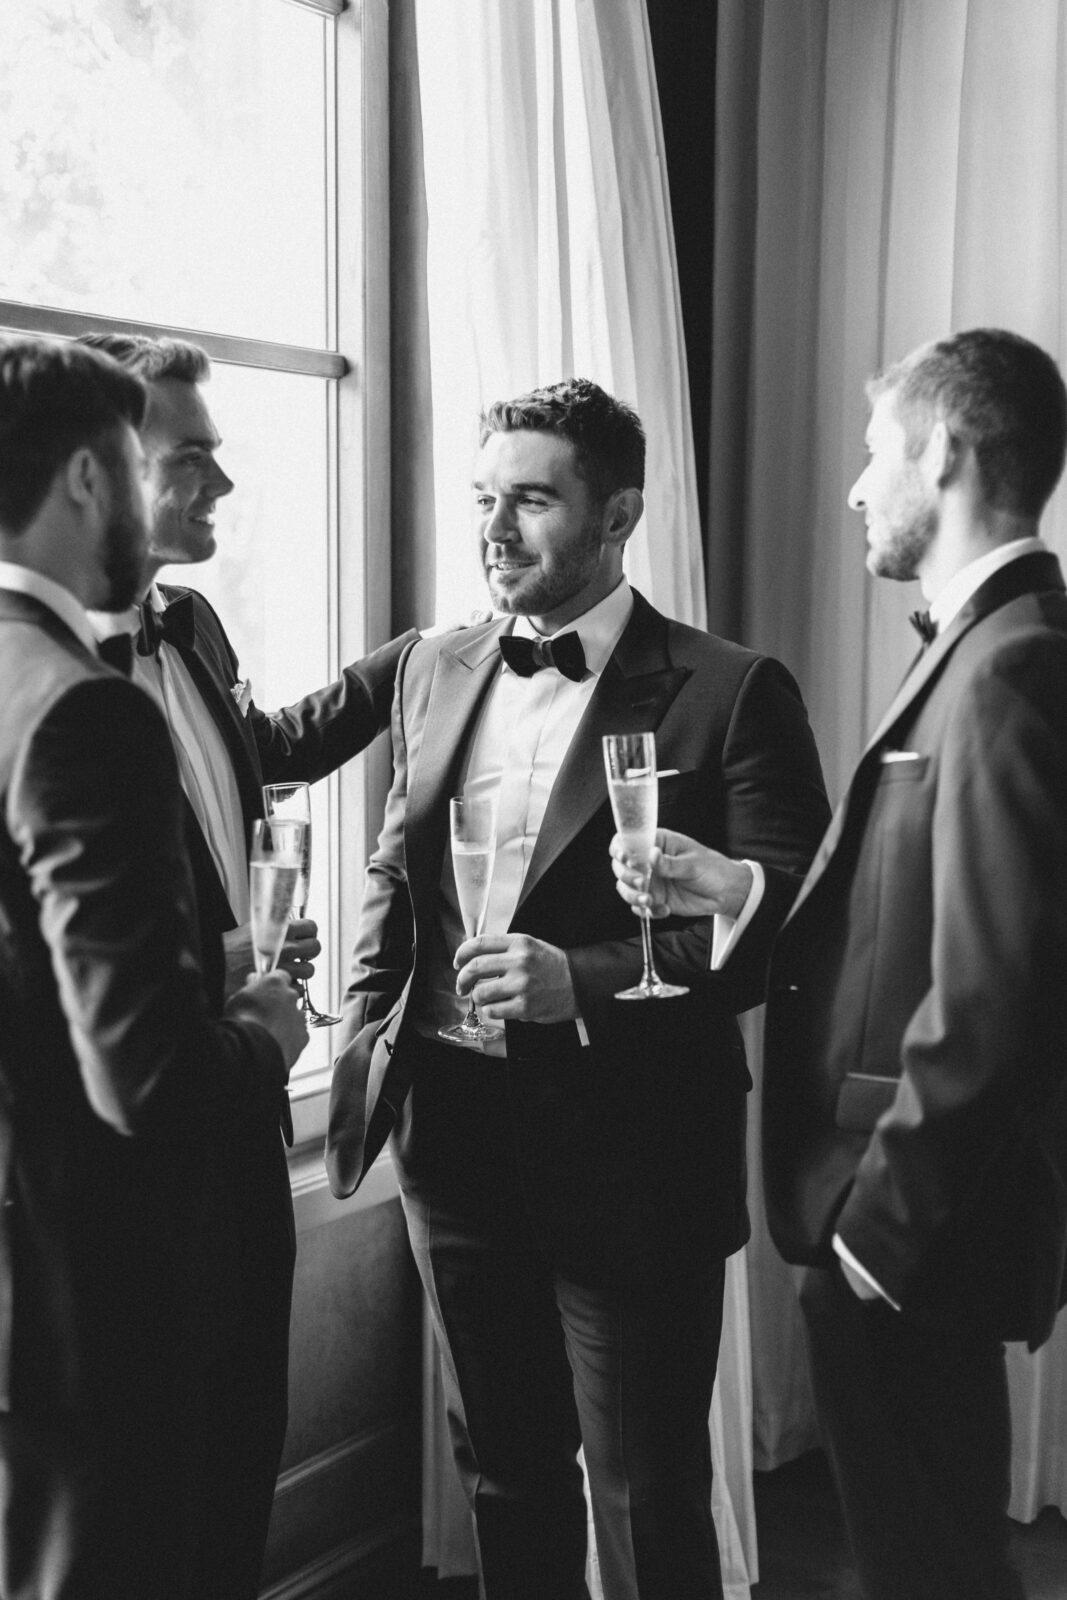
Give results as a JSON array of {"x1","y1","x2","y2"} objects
[{"x1": 0, "y1": 339, "x2": 307, "y2": 1600}]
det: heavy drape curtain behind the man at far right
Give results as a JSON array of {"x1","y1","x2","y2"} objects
[{"x1": 707, "y1": 0, "x2": 1067, "y2": 1518}]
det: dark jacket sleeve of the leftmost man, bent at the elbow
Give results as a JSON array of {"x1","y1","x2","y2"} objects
[{"x1": 8, "y1": 675, "x2": 285, "y2": 1136}]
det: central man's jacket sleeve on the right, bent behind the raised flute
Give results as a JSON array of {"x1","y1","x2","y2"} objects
[{"x1": 568, "y1": 656, "x2": 830, "y2": 1016}]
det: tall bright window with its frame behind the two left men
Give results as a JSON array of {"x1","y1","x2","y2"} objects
[{"x1": 0, "y1": 0, "x2": 389, "y2": 1090}]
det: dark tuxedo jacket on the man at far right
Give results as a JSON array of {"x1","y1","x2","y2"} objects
[{"x1": 765, "y1": 554, "x2": 1067, "y2": 1346}]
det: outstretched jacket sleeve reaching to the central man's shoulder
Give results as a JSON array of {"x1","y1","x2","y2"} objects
[{"x1": 248, "y1": 630, "x2": 419, "y2": 784}]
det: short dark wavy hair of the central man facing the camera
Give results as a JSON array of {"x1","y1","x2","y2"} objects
[{"x1": 478, "y1": 378, "x2": 645, "y2": 502}]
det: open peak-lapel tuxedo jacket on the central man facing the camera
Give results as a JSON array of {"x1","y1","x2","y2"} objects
[{"x1": 328, "y1": 595, "x2": 829, "y2": 1282}]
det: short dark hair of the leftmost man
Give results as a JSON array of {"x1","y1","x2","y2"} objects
[{"x1": 0, "y1": 338, "x2": 146, "y2": 534}]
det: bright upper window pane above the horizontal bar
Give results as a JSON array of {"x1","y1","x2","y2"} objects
[{"x1": 0, "y1": 0, "x2": 333, "y2": 344}]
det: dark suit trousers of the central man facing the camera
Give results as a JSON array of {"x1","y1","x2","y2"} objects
[{"x1": 402, "y1": 1045, "x2": 725, "y2": 1600}]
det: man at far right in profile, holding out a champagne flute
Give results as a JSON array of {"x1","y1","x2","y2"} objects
[{"x1": 614, "y1": 330, "x2": 1067, "y2": 1600}]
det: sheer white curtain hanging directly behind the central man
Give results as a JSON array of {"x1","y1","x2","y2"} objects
[{"x1": 416, "y1": 0, "x2": 755, "y2": 1600}]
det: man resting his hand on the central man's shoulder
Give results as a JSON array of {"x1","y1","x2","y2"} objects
[{"x1": 73, "y1": 334, "x2": 418, "y2": 1600}]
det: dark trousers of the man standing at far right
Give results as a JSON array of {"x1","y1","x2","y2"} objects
[{"x1": 800, "y1": 1267, "x2": 1022, "y2": 1600}]
